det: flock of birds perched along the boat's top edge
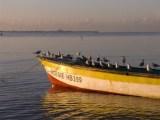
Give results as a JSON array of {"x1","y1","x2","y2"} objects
[{"x1": 34, "y1": 50, "x2": 160, "y2": 72}]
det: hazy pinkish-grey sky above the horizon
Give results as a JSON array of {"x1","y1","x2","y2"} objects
[{"x1": 0, "y1": 0, "x2": 160, "y2": 32}]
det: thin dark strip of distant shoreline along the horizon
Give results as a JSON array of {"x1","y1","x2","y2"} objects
[{"x1": 0, "y1": 30, "x2": 160, "y2": 37}]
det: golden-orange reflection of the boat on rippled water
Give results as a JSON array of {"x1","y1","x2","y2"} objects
[{"x1": 42, "y1": 87, "x2": 160, "y2": 120}]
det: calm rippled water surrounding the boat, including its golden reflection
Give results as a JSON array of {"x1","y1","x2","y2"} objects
[{"x1": 0, "y1": 33, "x2": 160, "y2": 120}]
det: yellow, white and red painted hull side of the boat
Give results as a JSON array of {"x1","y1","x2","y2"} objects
[{"x1": 40, "y1": 58, "x2": 160, "y2": 98}]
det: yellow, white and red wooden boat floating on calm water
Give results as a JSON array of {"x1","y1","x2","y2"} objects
[{"x1": 36, "y1": 51, "x2": 160, "y2": 99}]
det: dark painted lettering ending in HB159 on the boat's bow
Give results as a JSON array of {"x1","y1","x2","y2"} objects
[{"x1": 51, "y1": 71, "x2": 82, "y2": 83}]
